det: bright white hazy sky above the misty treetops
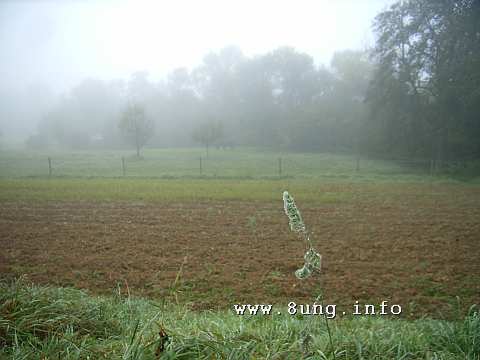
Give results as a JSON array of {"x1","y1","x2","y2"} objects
[{"x1": 0, "y1": 0, "x2": 393, "y2": 91}]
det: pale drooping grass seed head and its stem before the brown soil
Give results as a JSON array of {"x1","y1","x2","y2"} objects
[{"x1": 283, "y1": 191, "x2": 336, "y2": 359}]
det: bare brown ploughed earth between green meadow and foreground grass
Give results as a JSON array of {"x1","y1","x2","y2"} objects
[{"x1": 0, "y1": 192, "x2": 480, "y2": 317}]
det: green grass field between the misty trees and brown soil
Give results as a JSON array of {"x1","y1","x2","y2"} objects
[{"x1": 0, "y1": 149, "x2": 480, "y2": 202}]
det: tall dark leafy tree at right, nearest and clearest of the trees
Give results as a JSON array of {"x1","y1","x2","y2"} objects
[{"x1": 368, "y1": 0, "x2": 480, "y2": 159}]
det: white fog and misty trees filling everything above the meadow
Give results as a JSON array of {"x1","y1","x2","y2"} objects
[{"x1": 0, "y1": 0, "x2": 480, "y2": 161}]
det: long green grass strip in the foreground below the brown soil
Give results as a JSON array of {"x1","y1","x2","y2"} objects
[{"x1": 0, "y1": 282, "x2": 480, "y2": 359}]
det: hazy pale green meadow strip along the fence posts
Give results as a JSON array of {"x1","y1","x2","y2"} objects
[{"x1": 0, "y1": 151, "x2": 480, "y2": 178}]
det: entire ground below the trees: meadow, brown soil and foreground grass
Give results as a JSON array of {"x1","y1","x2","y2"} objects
[{"x1": 0, "y1": 149, "x2": 480, "y2": 359}]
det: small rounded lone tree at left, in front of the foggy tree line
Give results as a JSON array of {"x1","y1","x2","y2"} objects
[{"x1": 118, "y1": 104, "x2": 154, "y2": 157}]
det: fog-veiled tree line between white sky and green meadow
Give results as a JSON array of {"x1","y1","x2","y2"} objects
[{"x1": 27, "y1": 0, "x2": 480, "y2": 160}]
